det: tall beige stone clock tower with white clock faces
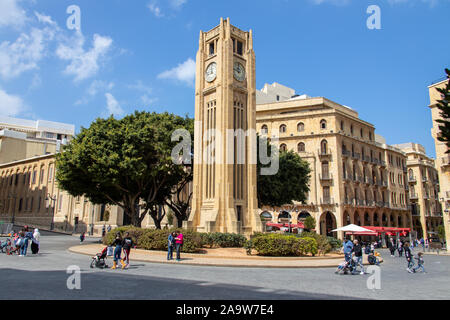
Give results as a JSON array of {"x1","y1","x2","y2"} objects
[{"x1": 185, "y1": 18, "x2": 262, "y2": 235}]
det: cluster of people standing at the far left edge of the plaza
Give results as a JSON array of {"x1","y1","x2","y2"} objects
[{"x1": 2, "y1": 226, "x2": 41, "y2": 257}]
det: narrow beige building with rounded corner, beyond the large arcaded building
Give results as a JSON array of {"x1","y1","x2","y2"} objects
[{"x1": 395, "y1": 143, "x2": 443, "y2": 239}]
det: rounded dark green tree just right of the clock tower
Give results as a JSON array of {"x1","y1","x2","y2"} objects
[{"x1": 257, "y1": 138, "x2": 311, "y2": 208}]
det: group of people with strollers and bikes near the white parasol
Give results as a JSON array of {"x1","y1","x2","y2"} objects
[{"x1": 342, "y1": 237, "x2": 426, "y2": 274}]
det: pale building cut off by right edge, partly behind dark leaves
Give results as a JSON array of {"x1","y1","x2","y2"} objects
[{"x1": 428, "y1": 79, "x2": 450, "y2": 244}]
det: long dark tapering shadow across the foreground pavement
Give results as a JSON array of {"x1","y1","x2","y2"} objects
[{"x1": 0, "y1": 269, "x2": 364, "y2": 300}]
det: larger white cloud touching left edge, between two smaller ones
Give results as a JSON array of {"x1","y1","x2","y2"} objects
[{"x1": 0, "y1": 28, "x2": 55, "y2": 79}]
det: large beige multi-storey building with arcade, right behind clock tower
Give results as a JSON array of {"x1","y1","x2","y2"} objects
[{"x1": 256, "y1": 84, "x2": 412, "y2": 237}]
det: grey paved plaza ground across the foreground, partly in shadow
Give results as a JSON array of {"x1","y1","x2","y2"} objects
[{"x1": 0, "y1": 233, "x2": 450, "y2": 300}]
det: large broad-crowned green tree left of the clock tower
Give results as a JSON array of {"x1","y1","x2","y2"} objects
[{"x1": 56, "y1": 111, "x2": 193, "y2": 227}]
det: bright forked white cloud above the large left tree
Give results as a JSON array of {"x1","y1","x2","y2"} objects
[{"x1": 56, "y1": 33, "x2": 113, "y2": 81}]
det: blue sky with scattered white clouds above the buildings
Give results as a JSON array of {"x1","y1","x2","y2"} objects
[{"x1": 0, "y1": 0, "x2": 450, "y2": 156}]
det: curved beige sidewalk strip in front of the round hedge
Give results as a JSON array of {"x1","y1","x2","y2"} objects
[{"x1": 69, "y1": 244, "x2": 382, "y2": 268}]
